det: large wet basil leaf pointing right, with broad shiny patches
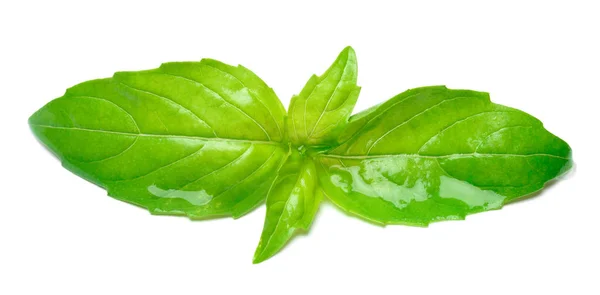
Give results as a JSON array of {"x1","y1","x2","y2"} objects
[{"x1": 318, "y1": 86, "x2": 572, "y2": 226}]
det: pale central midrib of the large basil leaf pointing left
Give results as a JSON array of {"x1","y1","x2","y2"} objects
[{"x1": 29, "y1": 124, "x2": 282, "y2": 145}]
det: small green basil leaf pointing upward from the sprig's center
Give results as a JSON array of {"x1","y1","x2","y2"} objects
[{"x1": 288, "y1": 47, "x2": 360, "y2": 146}]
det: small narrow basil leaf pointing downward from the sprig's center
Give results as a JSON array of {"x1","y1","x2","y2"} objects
[{"x1": 254, "y1": 151, "x2": 321, "y2": 263}]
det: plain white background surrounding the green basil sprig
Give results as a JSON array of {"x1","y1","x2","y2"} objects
[{"x1": 0, "y1": 0, "x2": 600, "y2": 295}]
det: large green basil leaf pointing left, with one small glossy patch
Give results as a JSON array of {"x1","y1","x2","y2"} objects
[{"x1": 29, "y1": 60, "x2": 288, "y2": 218}]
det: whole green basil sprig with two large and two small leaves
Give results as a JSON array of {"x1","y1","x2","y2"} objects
[{"x1": 29, "y1": 47, "x2": 572, "y2": 263}]
